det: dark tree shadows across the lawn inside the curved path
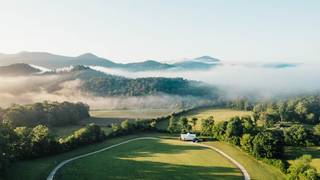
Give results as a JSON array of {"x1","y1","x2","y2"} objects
[{"x1": 55, "y1": 140, "x2": 243, "y2": 180}]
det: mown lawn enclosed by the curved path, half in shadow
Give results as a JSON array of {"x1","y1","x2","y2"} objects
[{"x1": 56, "y1": 139, "x2": 243, "y2": 180}]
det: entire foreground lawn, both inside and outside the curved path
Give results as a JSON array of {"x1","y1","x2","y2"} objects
[{"x1": 7, "y1": 133, "x2": 285, "y2": 180}]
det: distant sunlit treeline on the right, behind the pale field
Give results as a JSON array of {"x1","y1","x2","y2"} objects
[{"x1": 221, "y1": 95, "x2": 320, "y2": 127}]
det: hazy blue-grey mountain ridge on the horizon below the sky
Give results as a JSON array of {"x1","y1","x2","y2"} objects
[{"x1": 0, "y1": 52, "x2": 220, "y2": 71}]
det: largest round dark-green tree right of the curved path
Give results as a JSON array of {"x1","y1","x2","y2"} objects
[{"x1": 252, "y1": 131, "x2": 284, "y2": 158}]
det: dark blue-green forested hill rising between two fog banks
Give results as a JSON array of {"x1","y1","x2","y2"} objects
[{"x1": 82, "y1": 76, "x2": 213, "y2": 97}]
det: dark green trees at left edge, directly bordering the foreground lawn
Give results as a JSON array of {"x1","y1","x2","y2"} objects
[{"x1": 0, "y1": 124, "x2": 106, "y2": 175}]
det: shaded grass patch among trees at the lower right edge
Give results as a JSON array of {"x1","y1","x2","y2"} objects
[{"x1": 285, "y1": 146, "x2": 320, "y2": 173}]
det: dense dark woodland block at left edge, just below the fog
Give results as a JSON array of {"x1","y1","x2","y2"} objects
[{"x1": 0, "y1": 101, "x2": 90, "y2": 127}]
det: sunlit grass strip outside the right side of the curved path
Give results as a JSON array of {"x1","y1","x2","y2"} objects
[{"x1": 205, "y1": 141, "x2": 286, "y2": 180}]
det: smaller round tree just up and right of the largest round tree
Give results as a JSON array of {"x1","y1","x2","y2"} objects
[{"x1": 284, "y1": 125, "x2": 311, "y2": 146}]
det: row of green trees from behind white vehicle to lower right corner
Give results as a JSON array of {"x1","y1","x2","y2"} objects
[{"x1": 168, "y1": 116, "x2": 320, "y2": 179}]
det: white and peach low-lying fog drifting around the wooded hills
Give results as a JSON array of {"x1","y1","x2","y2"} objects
[{"x1": 0, "y1": 63, "x2": 320, "y2": 109}]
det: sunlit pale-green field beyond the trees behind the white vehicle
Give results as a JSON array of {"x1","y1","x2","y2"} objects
[{"x1": 157, "y1": 107, "x2": 252, "y2": 131}]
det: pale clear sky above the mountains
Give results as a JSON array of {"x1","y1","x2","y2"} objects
[{"x1": 0, "y1": 0, "x2": 320, "y2": 62}]
